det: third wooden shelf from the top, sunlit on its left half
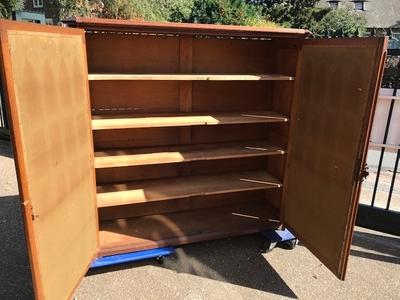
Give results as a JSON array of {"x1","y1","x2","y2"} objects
[{"x1": 94, "y1": 141, "x2": 286, "y2": 169}]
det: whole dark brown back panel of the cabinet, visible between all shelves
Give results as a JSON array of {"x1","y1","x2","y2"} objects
[{"x1": 87, "y1": 28, "x2": 295, "y2": 255}]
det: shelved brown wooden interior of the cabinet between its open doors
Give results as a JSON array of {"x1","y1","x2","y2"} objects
[{"x1": 86, "y1": 31, "x2": 301, "y2": 255}]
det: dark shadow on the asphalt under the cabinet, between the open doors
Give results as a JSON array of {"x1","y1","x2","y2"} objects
[{"x1": 88, "y1": 235, "x2": 297, "y2": 298}]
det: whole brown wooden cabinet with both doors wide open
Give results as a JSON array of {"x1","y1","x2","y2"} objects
[{"x1": 0, "y1": 18, "x2": 387, "y2": 298}]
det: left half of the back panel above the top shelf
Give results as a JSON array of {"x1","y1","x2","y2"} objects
[{"x1": 86, "y1": 33, "x2": 179, "y2": 73}]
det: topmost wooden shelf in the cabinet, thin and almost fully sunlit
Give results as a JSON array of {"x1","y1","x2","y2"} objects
[{"x1": 89, "y1": 74, "x2": 294, "y2": 81}]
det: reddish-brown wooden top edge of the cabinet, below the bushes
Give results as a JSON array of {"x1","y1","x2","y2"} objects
[{"x1": 63, "y1": 17, "x2": 310, "y2": 38}]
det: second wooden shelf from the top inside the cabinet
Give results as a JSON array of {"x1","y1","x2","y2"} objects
[{"x1": 92, "y1": 111, "x2": 289, "y2": 130}]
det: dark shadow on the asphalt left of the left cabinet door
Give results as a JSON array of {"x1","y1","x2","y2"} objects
[{"x1": 0, "y1": 196, "x2": 33, "y2": 299}]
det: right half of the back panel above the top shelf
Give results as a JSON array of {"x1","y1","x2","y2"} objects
[{"x1": 192, "y1": 38, "x2": 275, "y2": 74}]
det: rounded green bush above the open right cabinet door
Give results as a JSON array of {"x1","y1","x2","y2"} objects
[{"x1": 311, "y1": 8, "x2": 367, "y2": 37}]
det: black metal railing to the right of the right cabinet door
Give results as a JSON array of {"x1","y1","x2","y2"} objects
[{"x1": 357, "y1": 49, "x2": 400, "y2": 235}]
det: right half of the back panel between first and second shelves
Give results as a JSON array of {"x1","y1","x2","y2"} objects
[{"x1": 192, "y1": 81, "x2": 271, "y2": 111}]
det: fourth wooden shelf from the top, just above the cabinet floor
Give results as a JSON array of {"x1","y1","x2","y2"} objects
[{"x1": 97, "y1": 171, "x2": 282, "y2": 207}]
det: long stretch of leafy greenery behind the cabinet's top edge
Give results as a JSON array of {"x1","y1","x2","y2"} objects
[{"x1": 51, "y1": 0, "x2": 277, "y2": 27}]
